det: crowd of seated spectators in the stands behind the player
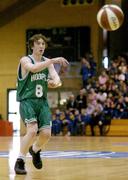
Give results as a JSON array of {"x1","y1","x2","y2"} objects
[{"x1": 52, "y1": 54, "x2": 128, "y2": 136}]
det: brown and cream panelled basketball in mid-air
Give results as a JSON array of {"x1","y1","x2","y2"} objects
[{"x1": 97, "y1": 4, "x2": 124, "y2": 31}]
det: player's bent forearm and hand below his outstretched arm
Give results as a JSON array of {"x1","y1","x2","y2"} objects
[{"x1": 48, "y1": 64, "x2": 62, "y2": 88}]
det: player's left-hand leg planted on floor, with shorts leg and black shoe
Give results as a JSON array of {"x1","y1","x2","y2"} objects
[{"x1": 14, "y1": 100, "x2": 38, "y2": 174}]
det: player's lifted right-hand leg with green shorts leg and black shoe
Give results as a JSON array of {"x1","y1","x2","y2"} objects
[{"x1": 29, "y1": 100, "x2": 51, "y2": 169}]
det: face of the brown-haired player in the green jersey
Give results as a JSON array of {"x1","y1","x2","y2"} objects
[{"x1": 32, "y1": 39, "x2": 46, "y2": 55}]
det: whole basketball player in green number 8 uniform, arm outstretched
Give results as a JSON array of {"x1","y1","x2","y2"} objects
[{"x1": 14, "y1": 34, "x2": 69, "y2": 174}]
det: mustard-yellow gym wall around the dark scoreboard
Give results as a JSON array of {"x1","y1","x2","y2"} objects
[{"x1": 0, "y1": 0, "x2": 100, "y2": 119}]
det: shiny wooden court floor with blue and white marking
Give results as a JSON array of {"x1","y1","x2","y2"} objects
[{"x1": 0, "y1": 136, "x2": 128, "y2": 180}]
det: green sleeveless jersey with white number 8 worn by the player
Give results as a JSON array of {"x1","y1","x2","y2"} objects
[{"x1": 17, "y1": 55, "x2": 48, "y2": 101}]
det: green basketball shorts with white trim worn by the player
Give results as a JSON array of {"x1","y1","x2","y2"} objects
[{"x1": 20, "y1": 98, "x2": 51, "y2": 130}]
